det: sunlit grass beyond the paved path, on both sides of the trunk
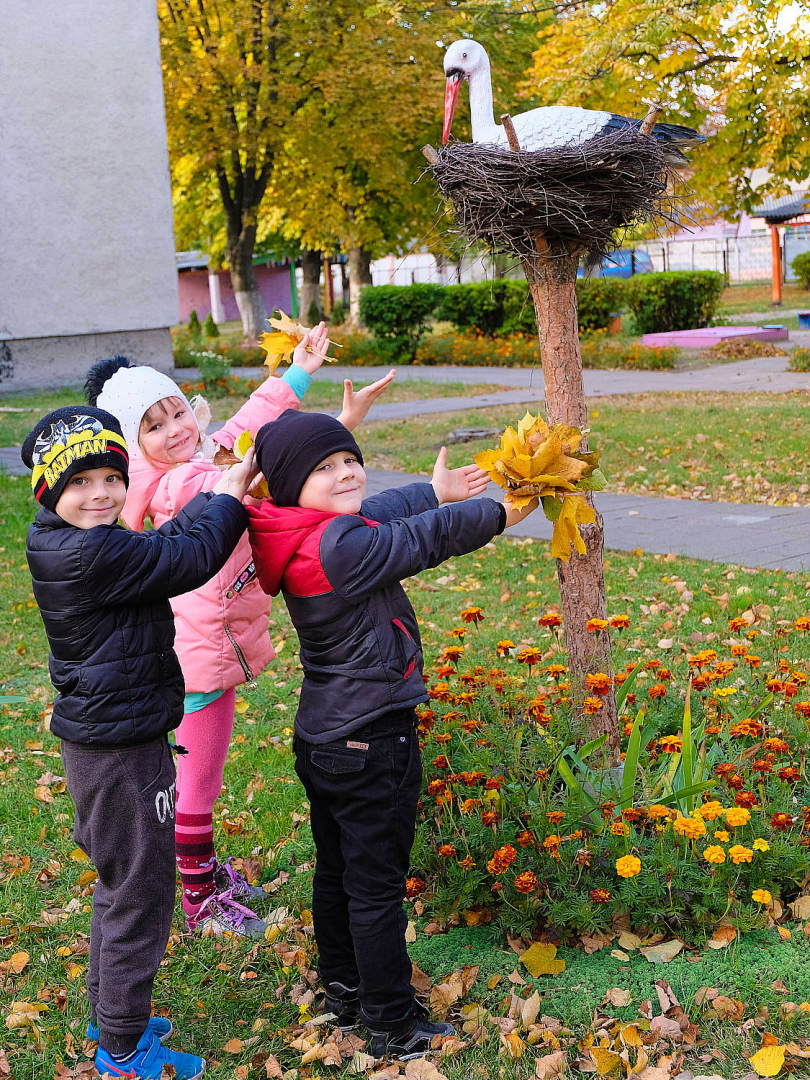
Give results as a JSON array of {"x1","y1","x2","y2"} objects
[{"x1": 361, "y1": 391, "x2": 810, "y2": 505}]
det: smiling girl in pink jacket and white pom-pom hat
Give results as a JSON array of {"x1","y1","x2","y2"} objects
[{"x1": 85, "y1": 323, "x2": 394, "y2": 937}]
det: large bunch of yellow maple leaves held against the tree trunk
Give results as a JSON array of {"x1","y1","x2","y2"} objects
[{"x1": 475, "y1": 413, "x2": 607, "y2": 562}]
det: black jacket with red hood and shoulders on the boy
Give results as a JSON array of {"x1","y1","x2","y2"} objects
[{"x1": 248, "y1": 484, "x2": 505, "y2": 743}]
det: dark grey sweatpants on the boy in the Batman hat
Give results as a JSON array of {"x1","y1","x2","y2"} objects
[{"x1": 62, "y1": 737, "x2": 175, "y2": 1054}]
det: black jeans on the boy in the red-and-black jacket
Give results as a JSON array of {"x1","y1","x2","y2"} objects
[{"x1": 294, "y1": 710, "x2": 422, "y2": 1031}]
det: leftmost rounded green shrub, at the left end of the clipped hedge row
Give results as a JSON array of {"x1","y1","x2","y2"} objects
[{"x1": 360, "y1": 284, "x2": 442, "y2": 363}]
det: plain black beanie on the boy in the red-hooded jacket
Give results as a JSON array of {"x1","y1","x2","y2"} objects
[{"x1": 256, "y1": 408, "x2": 363, "y2": 507}]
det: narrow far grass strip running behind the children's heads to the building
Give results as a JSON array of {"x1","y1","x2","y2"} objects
[{"x1": 0, "y1": 374, "x2": 511, "y2": 446}]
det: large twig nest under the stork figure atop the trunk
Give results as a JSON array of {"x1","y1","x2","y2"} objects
[{"x1": 430, "y1": 130, "x2": 677, "y2": 259}]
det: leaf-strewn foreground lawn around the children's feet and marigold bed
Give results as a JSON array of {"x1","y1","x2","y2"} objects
[{"x1": 0, "y1": 477, "x2": 810, "y2": 1080}]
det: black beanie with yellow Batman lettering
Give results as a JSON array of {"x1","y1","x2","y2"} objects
[{"x1": 21, "y1": 405, "x2": 130, "y2": 510}]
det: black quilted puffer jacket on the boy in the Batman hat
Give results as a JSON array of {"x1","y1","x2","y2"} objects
[{"x1": 26, "y1": 491, "x2": 247, "y2": 746}]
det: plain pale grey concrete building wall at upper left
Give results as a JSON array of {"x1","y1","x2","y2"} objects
[{"x1": 0, "y1": 0, "x2": 177, "y2": 390}]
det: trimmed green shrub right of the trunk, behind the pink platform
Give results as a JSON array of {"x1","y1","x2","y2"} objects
[{"x1": 625, "y1": 270, "x2": 726, "y2": 334}]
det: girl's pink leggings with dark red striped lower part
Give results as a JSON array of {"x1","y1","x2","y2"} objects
[{"x1": 174, "y1": 688, "x2": 237, "y2": 907}]
